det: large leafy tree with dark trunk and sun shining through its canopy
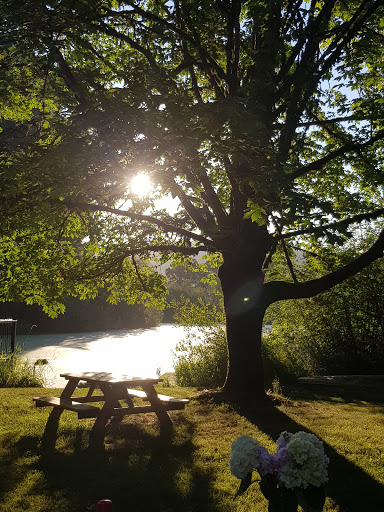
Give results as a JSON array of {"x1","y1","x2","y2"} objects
[{"x1": 0, "y1": 0, "x2": 384, "y2": 398}]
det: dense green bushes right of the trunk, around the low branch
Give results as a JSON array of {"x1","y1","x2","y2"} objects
[{"x1": 267, "y1": 236, "x2": 384, "y2": 376}]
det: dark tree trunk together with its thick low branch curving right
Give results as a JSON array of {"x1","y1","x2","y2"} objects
[{"x1": 219, "y1": 221, "x2": 384, "y2": 403}]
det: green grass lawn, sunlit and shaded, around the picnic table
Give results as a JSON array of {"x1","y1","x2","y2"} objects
[{"x1": 0, "y1": 382, "x2": 384, "y2": 512}]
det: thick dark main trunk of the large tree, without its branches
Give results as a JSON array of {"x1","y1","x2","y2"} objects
[{"x1": 219, "y1": 223, "x2": 271, "y2": 402}]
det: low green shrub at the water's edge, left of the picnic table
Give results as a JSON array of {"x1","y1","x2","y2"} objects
[{"x1": 0, "y1": 353, "x2": 44, "y2": 388}]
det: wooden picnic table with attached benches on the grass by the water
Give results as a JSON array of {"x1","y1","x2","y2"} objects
[{"x1": 33, "y1": 372, "x2": 188, "y2": 442}]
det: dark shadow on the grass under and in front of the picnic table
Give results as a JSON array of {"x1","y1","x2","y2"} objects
[{"x1": 1, "y1": 415, "x2": 222, "y2": 512}]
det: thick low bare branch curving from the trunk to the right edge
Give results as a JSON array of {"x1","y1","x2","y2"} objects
[{"x1": 264, "y1": 230, "x2": 384, "y2": 306}]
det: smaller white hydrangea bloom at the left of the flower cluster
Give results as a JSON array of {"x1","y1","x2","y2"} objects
[{"x1": 229, "y1": 436, "x2": 260, "y2": 480}]
